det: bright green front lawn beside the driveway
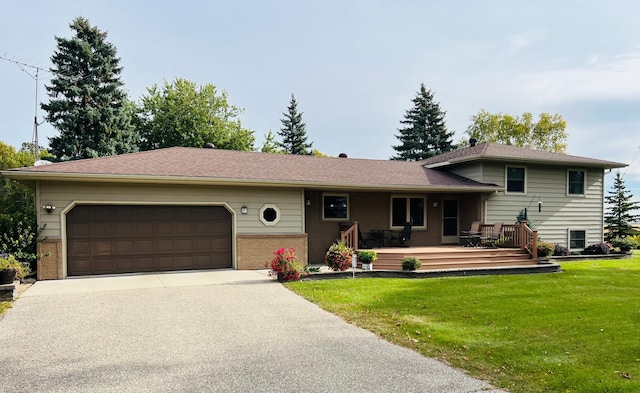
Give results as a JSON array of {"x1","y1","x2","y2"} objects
[{"x1": 287, "y1": 252, "x2": 640, "y2": 392}]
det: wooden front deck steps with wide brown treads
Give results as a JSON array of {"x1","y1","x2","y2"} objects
[{"x1": 358, "y1": 246, "x2": 538, "y2": 270}]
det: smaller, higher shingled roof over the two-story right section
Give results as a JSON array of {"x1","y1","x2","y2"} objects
[{"x1": 421, "y1": 143, "x2": 627, "y2": 169}]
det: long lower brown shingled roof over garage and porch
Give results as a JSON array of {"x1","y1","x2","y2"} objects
[{"x1": 2, "y1": 147, "x2": 501, "y2": 192}]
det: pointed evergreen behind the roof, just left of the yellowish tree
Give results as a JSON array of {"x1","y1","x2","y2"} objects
[{"x1": 391, "y1": 83, "x2": 456, "y2": 161}]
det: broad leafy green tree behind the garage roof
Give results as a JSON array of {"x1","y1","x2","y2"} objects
[{"x1": 139, "y1": 78, "x2": 255, "y2": 151}]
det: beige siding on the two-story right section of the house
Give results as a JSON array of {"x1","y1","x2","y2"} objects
[{"x1": 483, "y1": 163, "x2": 604, "y2": 245}]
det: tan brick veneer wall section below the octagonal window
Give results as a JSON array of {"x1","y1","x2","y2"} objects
[{"x1": 236, "y1": 234, "x2": 308, "y2": 270}]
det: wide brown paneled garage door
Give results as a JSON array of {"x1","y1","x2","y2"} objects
[{"x1": 67, "y1": 205, "x2": 232, "y2": 276}]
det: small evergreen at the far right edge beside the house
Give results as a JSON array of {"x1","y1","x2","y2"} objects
[{"x1": 604, "y1": 171, "x2": 640, "y2": 241}]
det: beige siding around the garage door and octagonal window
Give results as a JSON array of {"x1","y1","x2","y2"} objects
[{"x1": 37, "y1": 181, "x2": 304, "y2": 238}]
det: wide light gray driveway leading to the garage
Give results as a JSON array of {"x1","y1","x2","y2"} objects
[{"x1": 0, "y1": 271, "x2": 504, "y2": 393}]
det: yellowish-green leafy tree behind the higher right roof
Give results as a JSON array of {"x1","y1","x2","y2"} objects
[{"x1": 461, "y1": 109, "x2": 567, "y2": 153}]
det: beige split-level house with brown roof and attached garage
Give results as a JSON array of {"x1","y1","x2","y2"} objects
[{"x1": 2, "y1": 143, "x2": 625, "y2": 280}]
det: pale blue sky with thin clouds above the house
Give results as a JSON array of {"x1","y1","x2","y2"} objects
[{"x1": 0, "y1": 0, "x2": 640, "y2": 199}]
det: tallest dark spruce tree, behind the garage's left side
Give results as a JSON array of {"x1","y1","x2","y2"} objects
[{"x1": 42, "y1": 17, "x2": 139, "y2": 160}]
